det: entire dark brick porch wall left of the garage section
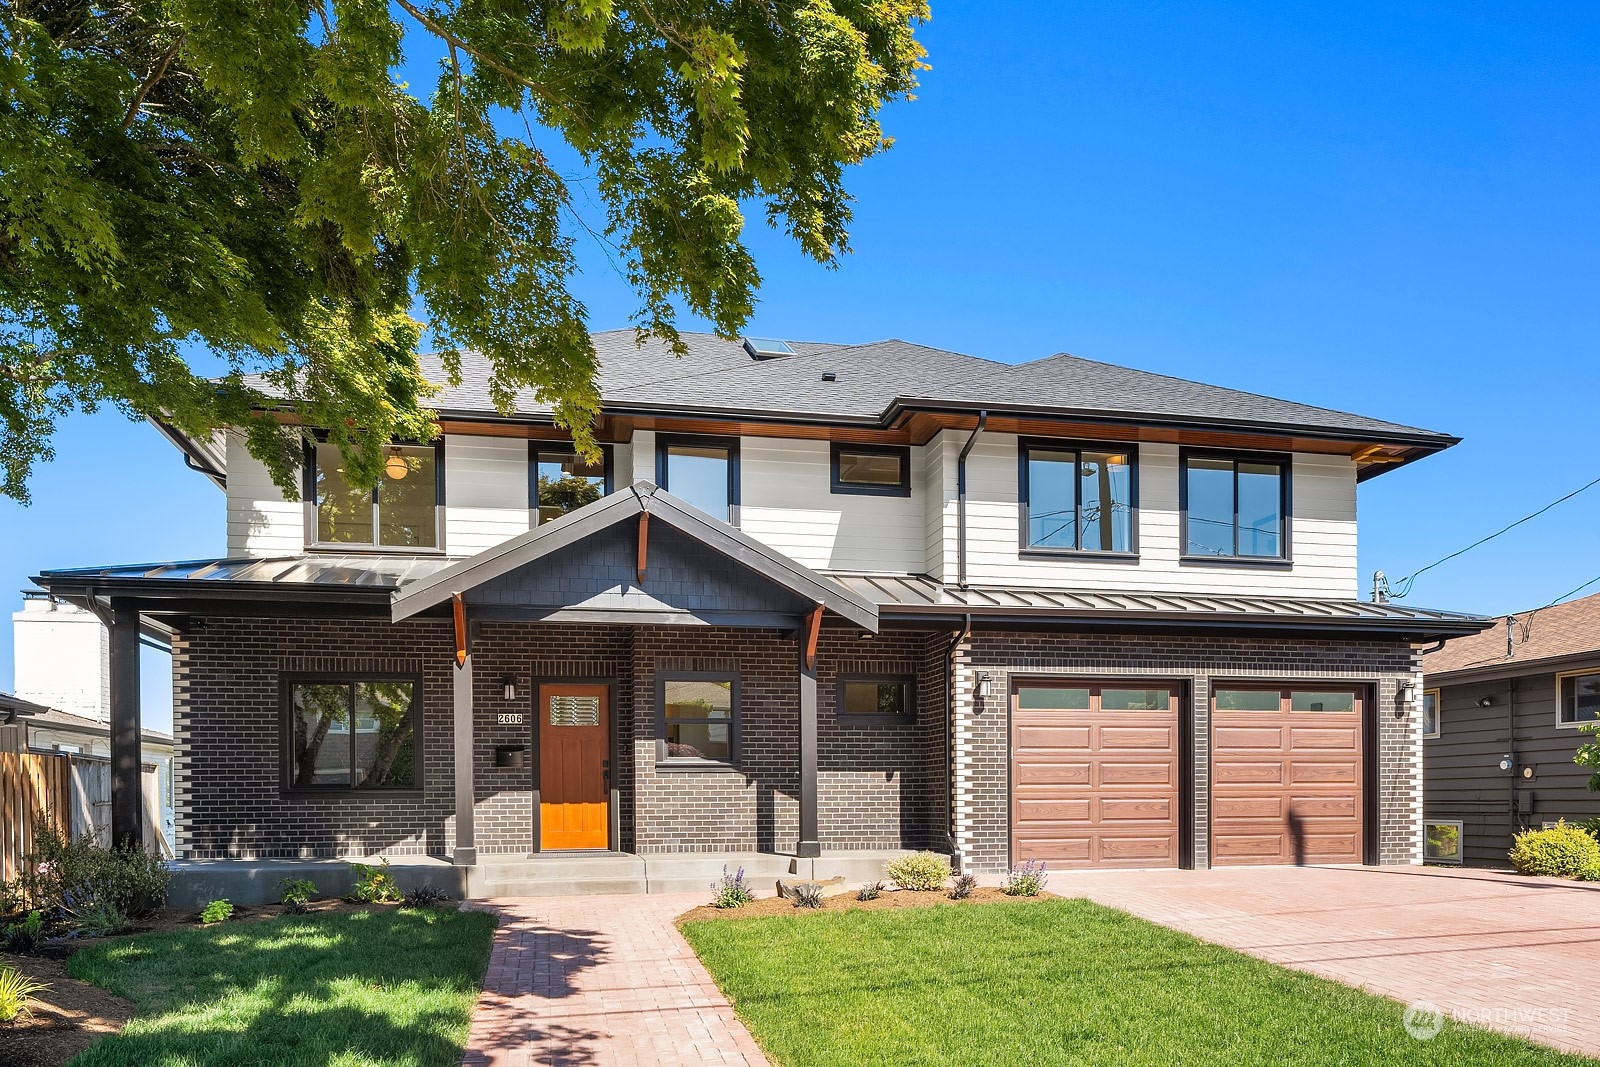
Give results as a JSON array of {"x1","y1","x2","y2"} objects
[{"x1": 173, "y1": 619, "x2": 947, "y2": 859}]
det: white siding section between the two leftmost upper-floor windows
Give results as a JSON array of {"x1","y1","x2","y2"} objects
[{"x1": 445, "y1": 434, "x2": 528, "y2": 555}]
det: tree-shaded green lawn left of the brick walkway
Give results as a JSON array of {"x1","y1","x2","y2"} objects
[{"x1": 69, "y1": 909, "x2": 494, "y2": 1067}]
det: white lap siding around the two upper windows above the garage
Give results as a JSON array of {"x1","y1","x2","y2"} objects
[{"x1": 946, "y1": 434, "x2": 1357, "y2": 598}]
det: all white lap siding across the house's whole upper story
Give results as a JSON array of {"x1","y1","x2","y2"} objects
[{"x1": 212, "y1": 419, "x2": 1360, "y2": 598}]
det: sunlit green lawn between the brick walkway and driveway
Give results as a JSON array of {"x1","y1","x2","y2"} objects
[{"x1": 683, "y1": 901, "x2": 1592, "y2": 1067}]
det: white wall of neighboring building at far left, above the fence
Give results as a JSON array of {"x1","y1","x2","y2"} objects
[{"x1": 11, "y1": 597, "x2": 110, "y2": 721}]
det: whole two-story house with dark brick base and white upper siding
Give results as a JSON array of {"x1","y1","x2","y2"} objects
[{"x1": 35, "y1": 331, "x2": 1483, "y2": 891}]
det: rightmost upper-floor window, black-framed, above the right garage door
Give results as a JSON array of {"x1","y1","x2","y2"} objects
[{"x1": 1182, "y1": 454, "x2": 1290, "y2": 560}]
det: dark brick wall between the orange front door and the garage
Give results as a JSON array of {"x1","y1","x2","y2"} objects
[{"x1": 632, "y1": 627, "x2": 946, "y2": 853}]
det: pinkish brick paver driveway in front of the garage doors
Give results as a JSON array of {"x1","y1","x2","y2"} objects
[{"x1": 1050, "y1": 867, "x2": 1600, "y2": 1056}]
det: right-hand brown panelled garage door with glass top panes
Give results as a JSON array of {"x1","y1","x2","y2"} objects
[{"x1": 1211, "y1": 685, "x2": 1363, "y2": 865}]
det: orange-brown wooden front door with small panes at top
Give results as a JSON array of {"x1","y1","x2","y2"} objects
[{"x1": 539, "y1": 685, "x2": 611, "y2": 849}]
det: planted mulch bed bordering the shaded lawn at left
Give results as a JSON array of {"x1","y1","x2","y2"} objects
[{"x1": 0, "y1": 901, "x2": 386, "y2": 1067}]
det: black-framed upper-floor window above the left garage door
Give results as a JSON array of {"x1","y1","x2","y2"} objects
[{"x1": 1018, "y1": 442, "x2": 1136, "y2": 553}]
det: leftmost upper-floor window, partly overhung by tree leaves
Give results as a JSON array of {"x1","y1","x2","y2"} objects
[{"x1": 310, "y1": 442, "x2": 443, "y2": 549}]
